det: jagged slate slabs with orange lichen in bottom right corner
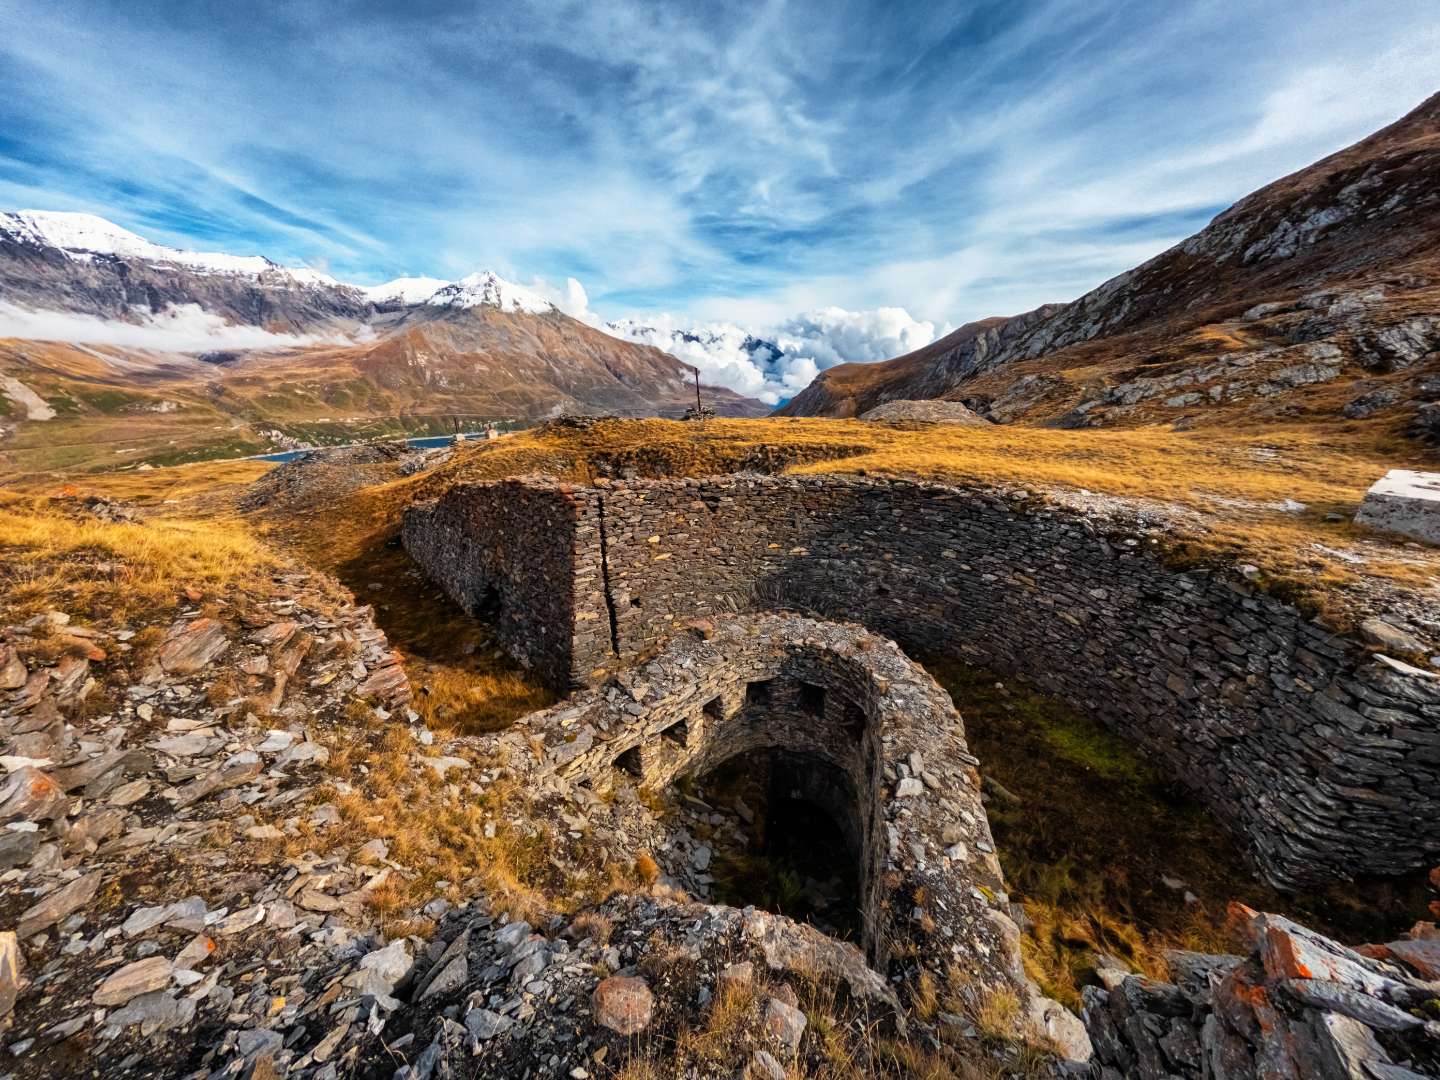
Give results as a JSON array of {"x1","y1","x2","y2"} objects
[{"x1": 1084, "y1": 906, "x2": 1440, "y2": 1080}]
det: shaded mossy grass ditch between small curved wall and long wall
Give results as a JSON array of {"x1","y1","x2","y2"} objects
[{"x1": 926, "y1": 660, "x2": 1428, "y2": 1005}]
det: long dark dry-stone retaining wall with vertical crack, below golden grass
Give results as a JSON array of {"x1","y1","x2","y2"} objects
[{"x1": 406, "y1": 475, "x2": 1440, "y2": 884}]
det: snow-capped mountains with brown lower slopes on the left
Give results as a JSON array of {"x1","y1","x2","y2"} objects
[{"x1": 0, "y1": 212, "x2": 768, "y2": 472}]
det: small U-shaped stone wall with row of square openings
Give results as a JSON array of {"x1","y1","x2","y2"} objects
[{"x1": 483, "y1": 615, "x2": 1025, "y2": 988}]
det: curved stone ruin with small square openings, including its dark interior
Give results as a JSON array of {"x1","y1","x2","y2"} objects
[{"x1": 495, "y1": 613, "x2": 1020, "y2": 981}]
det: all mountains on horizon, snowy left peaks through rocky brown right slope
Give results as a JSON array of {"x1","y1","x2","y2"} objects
[{"x1": 11, "y1": 84, "x2": 1440, "y2": 465}]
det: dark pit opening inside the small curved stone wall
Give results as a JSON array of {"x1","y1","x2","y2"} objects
[{"x1": 681, "y1": 747, "x2": 864, "y2": 943}]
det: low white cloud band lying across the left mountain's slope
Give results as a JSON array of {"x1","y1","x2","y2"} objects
[{"x1": 0, "y1": 302, "x2": 356, "y2": 353}]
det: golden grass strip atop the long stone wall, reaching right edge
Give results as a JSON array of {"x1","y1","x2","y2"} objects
[{"x1": 411, "y1": 418, "x2": 1440, "y2": 626}]
